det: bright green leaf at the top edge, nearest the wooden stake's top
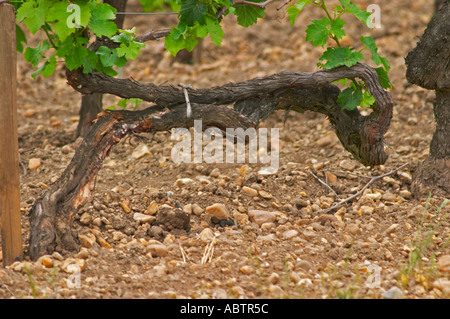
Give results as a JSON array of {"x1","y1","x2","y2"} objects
[{"x1": 16, "y1": 0, "x2": 52, "y2": 34}]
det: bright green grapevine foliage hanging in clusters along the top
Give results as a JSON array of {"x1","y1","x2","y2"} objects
[{"x1": 12, "y1": 0, "x2": 392, "y2": 110}]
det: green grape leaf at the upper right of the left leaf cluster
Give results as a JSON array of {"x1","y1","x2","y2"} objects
[{"x1": 89, "y1": 2, "x2": 117, "y2": 38}]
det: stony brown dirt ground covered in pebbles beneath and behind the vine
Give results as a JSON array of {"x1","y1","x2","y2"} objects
[{"x1": 0, "y1": 0, "x2": 450, "y2": 299}]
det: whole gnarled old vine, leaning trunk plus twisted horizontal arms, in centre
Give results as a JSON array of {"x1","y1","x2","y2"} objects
[{"x1": 29, "y1": 64, "x2": 393, "y2": 259}]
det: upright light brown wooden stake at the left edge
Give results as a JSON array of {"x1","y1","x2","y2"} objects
[{"x1": 0, "y1": 4, "x2": 22, "y2": 266}]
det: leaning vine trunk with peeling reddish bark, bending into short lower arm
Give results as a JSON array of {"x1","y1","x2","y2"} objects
[{"x1": 28, "y1": 105, "x2": 255, "y2": 260}]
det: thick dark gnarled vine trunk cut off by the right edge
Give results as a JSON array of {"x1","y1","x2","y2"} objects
[{"x1": 406, "y1": 0, "x2": 450, "y2": 197}]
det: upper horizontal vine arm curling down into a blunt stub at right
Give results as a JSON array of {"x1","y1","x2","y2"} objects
[{"x1": 67, "y1": 63, "x2": 393, "y2": 166}]
